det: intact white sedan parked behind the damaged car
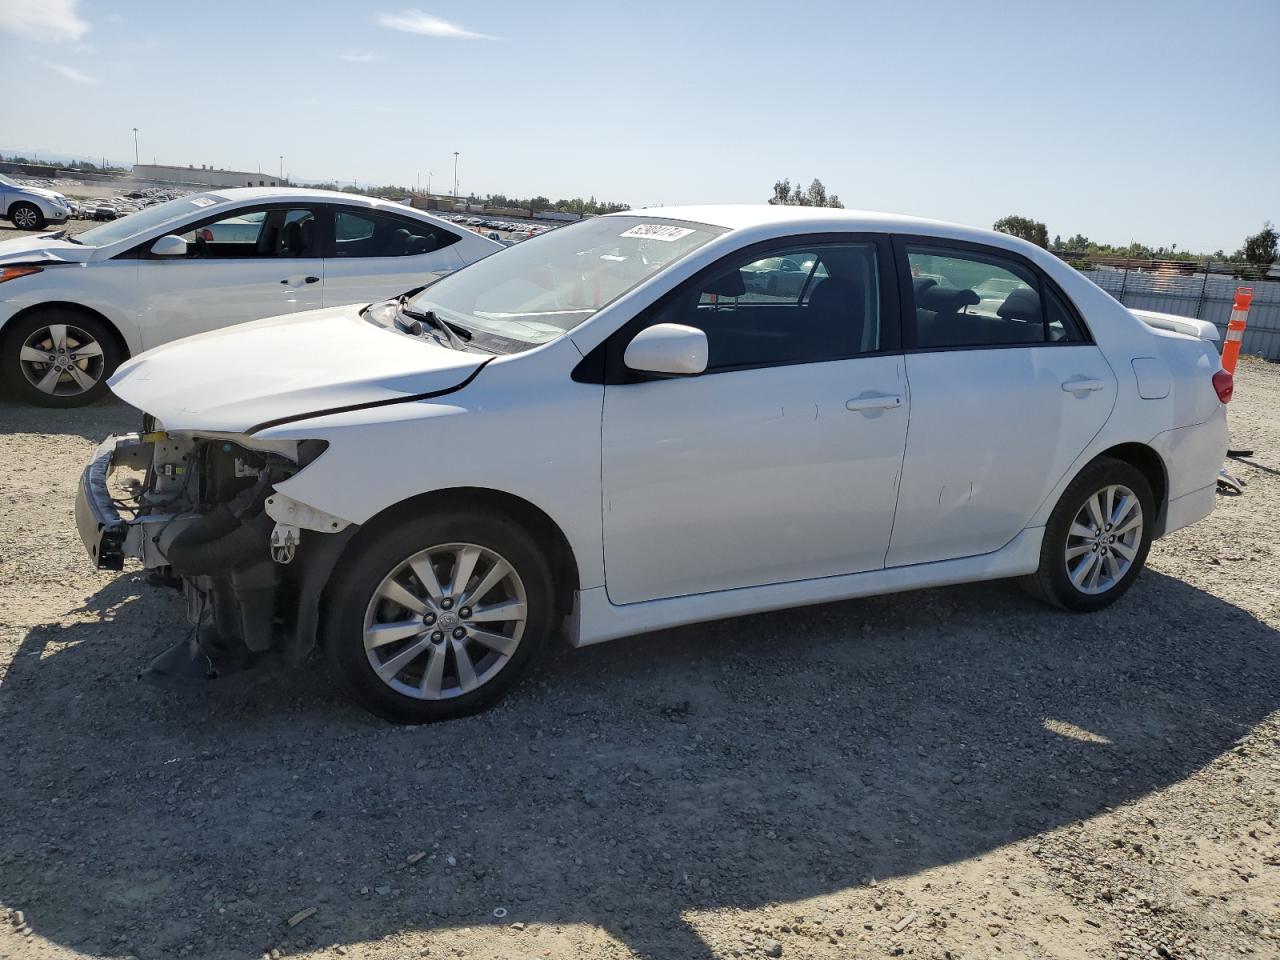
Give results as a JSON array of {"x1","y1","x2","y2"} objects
[{"x1": 0, "y1": 188, "x2": 502, "y2": 407}]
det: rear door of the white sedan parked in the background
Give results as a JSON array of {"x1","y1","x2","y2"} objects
[{"x1": 318, "y1": 205, "x2": 462, "y2": 306}]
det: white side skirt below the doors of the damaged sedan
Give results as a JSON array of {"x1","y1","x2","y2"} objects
[{"x1": 564, "y1": 527, "x2": 1044, "y2": 646}]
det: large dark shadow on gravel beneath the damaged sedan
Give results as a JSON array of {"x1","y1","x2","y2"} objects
[{"x1": 0, "y1": 571, "x2": 1280, "y2": 959}]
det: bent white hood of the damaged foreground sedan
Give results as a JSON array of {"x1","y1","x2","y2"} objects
[{"x1": 110, "y1": 305, "x2": 490, "y2": 433}]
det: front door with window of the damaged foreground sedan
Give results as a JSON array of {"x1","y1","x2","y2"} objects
[{"x1": 602, "y1": 234, "x2": 908, "y2": 604}]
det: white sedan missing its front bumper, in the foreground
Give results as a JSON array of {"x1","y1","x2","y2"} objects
[{"x1": 77, "y1": 206, "x2": 1231, "y2": 722}]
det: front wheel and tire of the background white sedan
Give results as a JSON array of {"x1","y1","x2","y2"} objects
[{"x1": 3, "y1": 310, "x2": 120, "y2": 407}]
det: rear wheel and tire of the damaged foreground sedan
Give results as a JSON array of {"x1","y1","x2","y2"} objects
[{"x1": 1021, "y1": 457, "x2": 1156, "y2": 613}]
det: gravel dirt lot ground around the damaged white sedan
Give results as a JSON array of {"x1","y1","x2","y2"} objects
[{"x1": 0, "y1": 362, "x2": 1280, "y2": 960}]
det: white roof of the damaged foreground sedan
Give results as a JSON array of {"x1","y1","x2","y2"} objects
[{"x1": 605, "y1": 204, "x2": 1039, "y2": 253}]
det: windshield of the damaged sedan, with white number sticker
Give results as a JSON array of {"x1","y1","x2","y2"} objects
[{"x1": 408, "y1": 216, "x2": 724, "y2": 343}]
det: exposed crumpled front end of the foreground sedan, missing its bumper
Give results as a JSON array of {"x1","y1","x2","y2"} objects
[{"x1": 76, "y1": 429, "x2": 357, "y2": 677}]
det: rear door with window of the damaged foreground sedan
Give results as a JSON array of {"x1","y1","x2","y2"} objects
[{"x1": 887, "y1": 238, "x2": 1116, "y2": 567}]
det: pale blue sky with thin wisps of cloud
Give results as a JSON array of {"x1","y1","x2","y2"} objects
[{"x1": 0, "y1": 0, "x2": 1280, "y2": 252}]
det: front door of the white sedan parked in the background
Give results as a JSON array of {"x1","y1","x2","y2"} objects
[{"x1": 137, "y1": 206, "x2": 325, "y2": 348}]
